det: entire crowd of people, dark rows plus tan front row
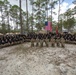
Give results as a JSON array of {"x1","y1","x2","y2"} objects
[{"x1": 0, "y1": 33, "x2": 76, "y2": 47}]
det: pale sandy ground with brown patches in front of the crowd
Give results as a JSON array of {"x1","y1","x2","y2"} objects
[{"x1": 0, "y1": 43, "x2": 76, "y2": 75}]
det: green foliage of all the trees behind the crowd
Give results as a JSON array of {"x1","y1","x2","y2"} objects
[{"x1": 0, "y1": 0, "x2": 76, "y2": 34}]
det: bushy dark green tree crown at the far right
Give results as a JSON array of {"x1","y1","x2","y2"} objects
[{"x1": 59, "y1": 9, "x2": 76, "y2": 31}]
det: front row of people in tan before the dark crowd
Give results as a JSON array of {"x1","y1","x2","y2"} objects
[{"x1": 31, "y1": 37, "x2": 65, "y2": 47}]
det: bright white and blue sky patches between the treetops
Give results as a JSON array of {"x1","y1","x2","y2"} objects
[{"x1": 8, "y1": 0, "x2": 75, "y2": 21}]
